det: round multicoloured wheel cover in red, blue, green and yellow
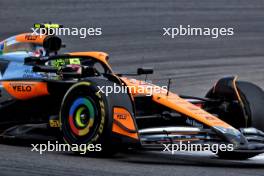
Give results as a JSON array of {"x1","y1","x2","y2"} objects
[{"x1": 68, "y1": 98, "x2": 95, "y2": 136}]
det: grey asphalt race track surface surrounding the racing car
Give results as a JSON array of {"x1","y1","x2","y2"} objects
[{"x1": 0, "y1": 0, "x2": 264, "y2": 176}]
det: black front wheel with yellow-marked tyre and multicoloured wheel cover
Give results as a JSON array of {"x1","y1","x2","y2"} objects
[{"x1": 60, "y1": 82, "x2": 114, "y2": 156}]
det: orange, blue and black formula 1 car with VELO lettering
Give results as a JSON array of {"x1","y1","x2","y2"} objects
[{"x1": 0, "y1": 25, "x2": 264, "y2": 159}]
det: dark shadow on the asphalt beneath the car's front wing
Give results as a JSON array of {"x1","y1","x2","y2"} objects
[{"x1": 115, "y1": 151, "x2": 264, "y2": 168}]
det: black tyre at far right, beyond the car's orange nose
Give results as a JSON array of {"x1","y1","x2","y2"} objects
[{"x1": 206, "y1": 77, "x2": 264, "y2": 131}]
